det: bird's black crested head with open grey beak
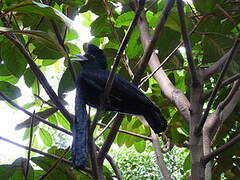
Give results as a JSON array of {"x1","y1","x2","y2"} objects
[{"x1": 73, "y1": 44, "x2": 107, "y2": 70}]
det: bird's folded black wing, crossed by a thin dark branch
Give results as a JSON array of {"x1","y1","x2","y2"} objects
[{"x1": 81, "y1": 70, "x2": 156, "y2": 105}]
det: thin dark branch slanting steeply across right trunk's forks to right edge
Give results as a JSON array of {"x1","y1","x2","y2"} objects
[{"x1": 195, "y1": 39, "x2": 240, "y2": 134}]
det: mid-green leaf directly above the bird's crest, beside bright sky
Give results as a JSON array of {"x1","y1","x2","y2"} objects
[{"x1": 91, "y1": 16, "x2": 112, "y2": 37}]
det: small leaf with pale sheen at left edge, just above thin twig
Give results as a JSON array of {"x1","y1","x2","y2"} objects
[{"x1": 0, "y1": 81, "x2": 22, "y2": 100}]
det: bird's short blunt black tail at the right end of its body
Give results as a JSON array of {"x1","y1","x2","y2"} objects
[{"x1": 143, "y1": 109, "x2": 167, "y2": 134}]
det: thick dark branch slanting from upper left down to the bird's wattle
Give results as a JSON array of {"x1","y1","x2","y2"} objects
[{"x1": 5, "y1": 34, "x2": 72, "y2": 123}]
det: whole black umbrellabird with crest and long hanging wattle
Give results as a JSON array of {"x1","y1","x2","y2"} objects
[{"x1": 72, "y1": 44, "x2": 167, "y2": 169}]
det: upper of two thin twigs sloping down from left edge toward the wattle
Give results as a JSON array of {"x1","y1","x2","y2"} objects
[{"x1": 0, "y1": 91, "x2": 72, "y2": 135}]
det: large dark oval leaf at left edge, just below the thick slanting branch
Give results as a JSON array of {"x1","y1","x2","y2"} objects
[{"x1": 0, "y1": 39, "x2": 27, "y2": 77}]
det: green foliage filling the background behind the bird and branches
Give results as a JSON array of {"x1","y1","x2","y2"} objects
[{"x1": 0, "y1": 0, "x2": 240, "y2": 179}]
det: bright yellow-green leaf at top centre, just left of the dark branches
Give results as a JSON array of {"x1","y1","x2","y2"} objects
[{"x1": 115, "y1": 11, "x2": 135, "y2": 28}]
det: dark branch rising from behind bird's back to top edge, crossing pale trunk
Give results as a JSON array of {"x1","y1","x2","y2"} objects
[{"x1": 133, "y1": 0, "x2": 175, "y2": 84}]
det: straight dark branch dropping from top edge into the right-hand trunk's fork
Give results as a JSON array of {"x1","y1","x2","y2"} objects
[{"x1": 177, "y1": 0, "x2": 200, "y2": 87}]
